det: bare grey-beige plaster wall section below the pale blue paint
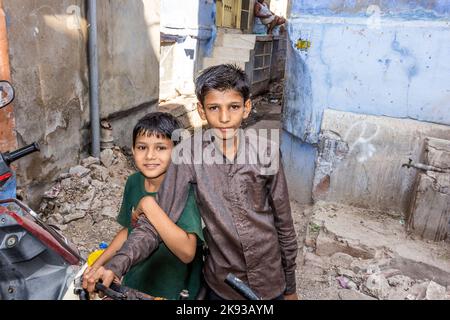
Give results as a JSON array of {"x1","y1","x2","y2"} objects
[{"x1": 313, "y1": 110, "x2": 450, "y2": 212}]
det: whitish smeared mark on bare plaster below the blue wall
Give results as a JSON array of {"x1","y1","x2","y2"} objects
[{"x1": 344, "y1": 121, "x2": 380, "y2": 163}]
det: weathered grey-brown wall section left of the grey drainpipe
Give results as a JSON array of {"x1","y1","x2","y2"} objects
[{"x1": 4, "y1": 0, "x2": 89, "y2": 206}]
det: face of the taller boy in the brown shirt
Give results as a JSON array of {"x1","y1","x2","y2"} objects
[{"x1": 197, "y1": 90, "x2": 252, "y2": 140}]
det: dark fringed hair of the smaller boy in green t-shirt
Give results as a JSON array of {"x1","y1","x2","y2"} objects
[{"x1": 133, "y1": 112, "x2": 181, "y2": 148}]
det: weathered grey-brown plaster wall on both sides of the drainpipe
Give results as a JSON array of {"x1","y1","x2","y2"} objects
[{"x1": 4, "y1": 0, "x2": 159, "y2": 208}]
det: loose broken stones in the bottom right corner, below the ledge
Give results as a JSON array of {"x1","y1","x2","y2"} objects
[{"x1": 302, "y1": 252, "x2": 450, "y2": 300}]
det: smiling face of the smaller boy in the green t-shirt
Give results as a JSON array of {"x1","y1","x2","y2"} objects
[{"x1": 133, "y1": 134, "x2": 173, "y2": 179}]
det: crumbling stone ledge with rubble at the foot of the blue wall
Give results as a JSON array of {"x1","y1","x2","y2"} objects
[{"x1": 297, "y1": 202, "x2": 450, "y2": 300}]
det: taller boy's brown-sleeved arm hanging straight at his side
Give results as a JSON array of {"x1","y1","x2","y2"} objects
[{"x1": 269, "y1": 157, "x2": 298, "y2": 296}]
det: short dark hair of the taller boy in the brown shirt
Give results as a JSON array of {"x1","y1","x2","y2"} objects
[{"x1": 195, "y1": 64, "x2": 250, "y2": 104}]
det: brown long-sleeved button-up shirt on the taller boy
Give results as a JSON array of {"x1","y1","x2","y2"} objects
[{"x1": 106, "y1": 131, "x2": 297, "y2": 299}]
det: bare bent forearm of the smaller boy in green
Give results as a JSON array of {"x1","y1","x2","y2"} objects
[{"x1": 136, "y1": 196, "x2": 197, "y2": 264}]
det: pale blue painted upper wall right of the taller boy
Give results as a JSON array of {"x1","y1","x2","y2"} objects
[{"x1": 283, "y1": 0, "x2": 450, "y2": 209}]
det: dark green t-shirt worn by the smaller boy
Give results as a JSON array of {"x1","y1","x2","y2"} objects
[{"x1": 117, "y1": 172, "x2": 204, "y2": 300}]
